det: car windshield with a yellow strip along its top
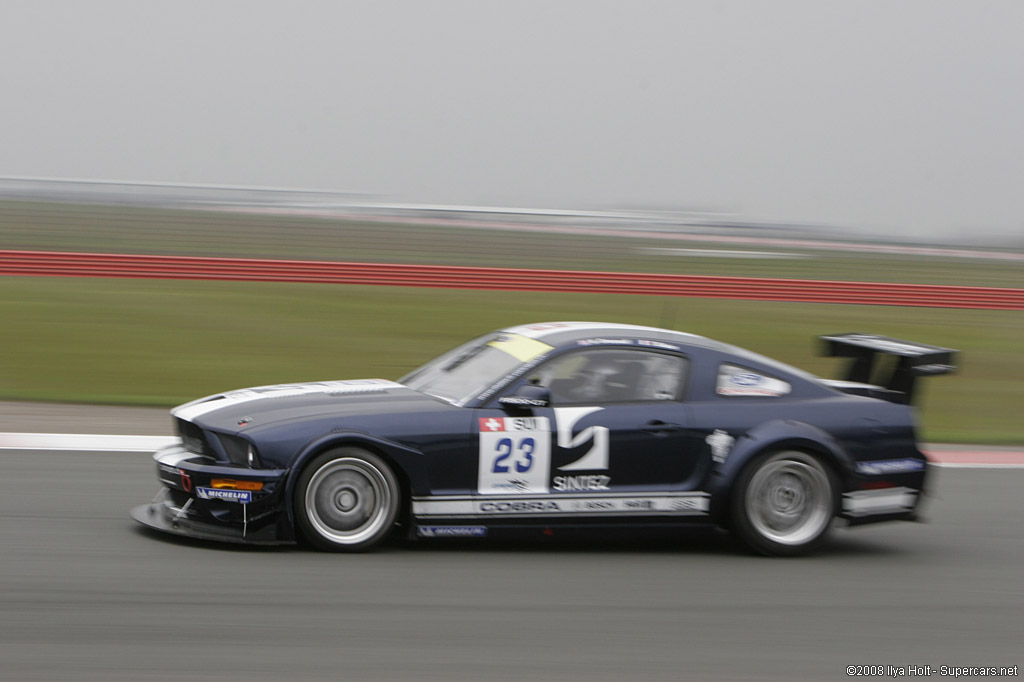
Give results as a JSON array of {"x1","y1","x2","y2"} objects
[{"x1": 398, "y1": 333, "x2": 551, "y2": 406}]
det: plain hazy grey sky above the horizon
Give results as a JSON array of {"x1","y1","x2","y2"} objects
[{"x1": 0, "y1": 0, "x2": 1024, "y2": 235}]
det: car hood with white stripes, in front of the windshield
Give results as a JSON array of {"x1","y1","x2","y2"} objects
[{"x1": 171, "y1": 379, "x2": 446, "y2": 431}]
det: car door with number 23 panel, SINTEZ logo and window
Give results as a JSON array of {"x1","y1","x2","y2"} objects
[{"x1": 477, "y1": 348, "x2": 702, "y2": 515}]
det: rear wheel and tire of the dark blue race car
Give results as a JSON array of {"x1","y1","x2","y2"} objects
[{"x1": 730, "y1": 451, "x2": 838, "y2": 556}]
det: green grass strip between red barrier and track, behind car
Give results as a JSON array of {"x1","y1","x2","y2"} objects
[{"x1": 0, "y1": 276, "x2": 1024, "y2": 443}]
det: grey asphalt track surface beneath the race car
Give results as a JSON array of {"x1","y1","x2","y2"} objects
[{"x1": 0, "y1": 450, "x2": 1024, "y2": 681}]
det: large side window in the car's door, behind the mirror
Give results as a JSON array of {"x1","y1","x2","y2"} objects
[{"x1": 526, "y1": 348, "x2": 686, "y2": 404}]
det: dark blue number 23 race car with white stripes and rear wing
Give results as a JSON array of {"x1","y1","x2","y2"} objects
[{"x1": 131, "y1": 322, "x2": 955, "y2": 555}]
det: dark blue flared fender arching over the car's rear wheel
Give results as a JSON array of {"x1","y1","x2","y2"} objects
[{"x1": 708, "y1": 419, "x2": 854, "y2": 522}]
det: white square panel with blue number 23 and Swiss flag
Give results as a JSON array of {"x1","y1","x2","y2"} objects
[{"x1": 476, "y1": 417, "x2": 551, "y2": 495}]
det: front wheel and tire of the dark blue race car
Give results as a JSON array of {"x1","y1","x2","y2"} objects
[{"x1": 295, "y1": 446, "x2": 401, "y2": 552}]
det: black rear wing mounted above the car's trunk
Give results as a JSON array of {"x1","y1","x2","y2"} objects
[{"x1": 821, "y1": 334, "x2": 956, "y2": 403}]
